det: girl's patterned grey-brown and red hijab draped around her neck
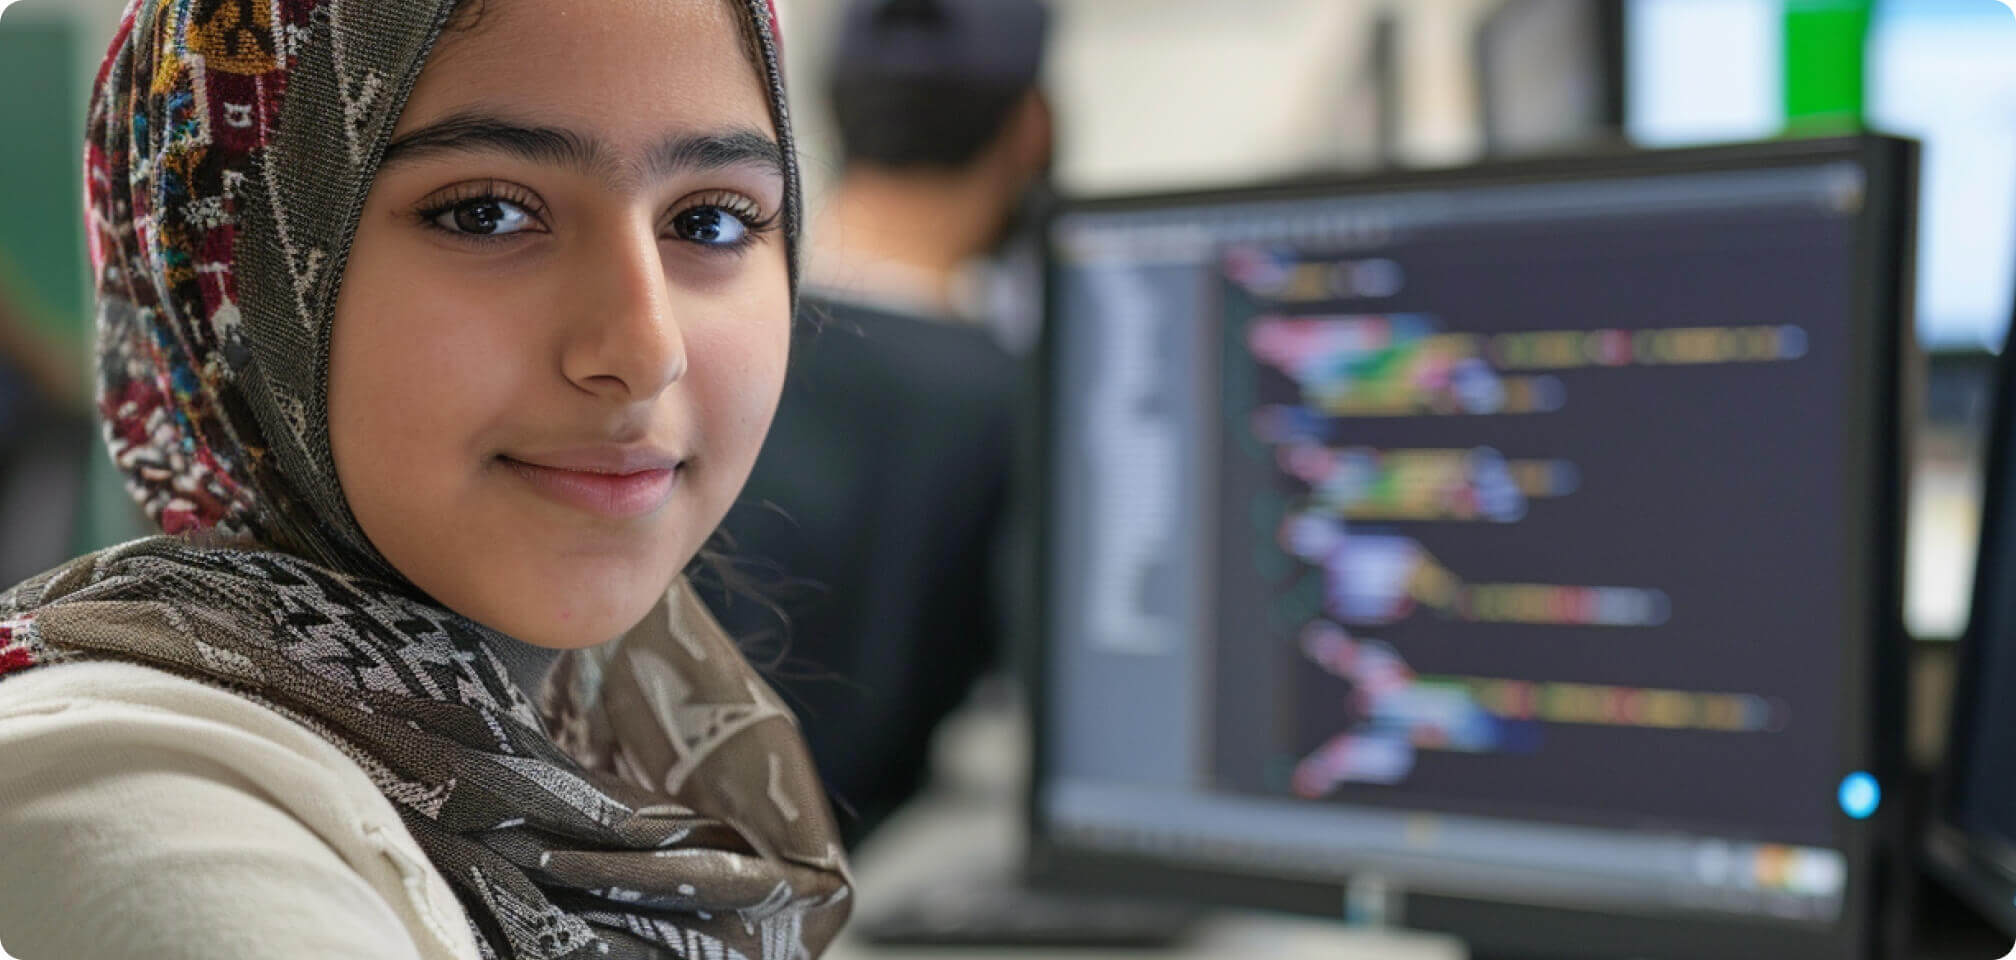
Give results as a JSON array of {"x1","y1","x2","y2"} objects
[{"x1": 0, "y1": 0, "x2": 851, "y2": 960}]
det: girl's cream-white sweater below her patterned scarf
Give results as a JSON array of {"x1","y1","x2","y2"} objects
[{"x1": 0, "y1": 664, "x2": 478, "y2": 960}]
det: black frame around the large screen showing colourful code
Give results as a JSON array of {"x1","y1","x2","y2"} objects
[{"x1": 1020, "y1": 133, "x2": 1917, "y2": 960}]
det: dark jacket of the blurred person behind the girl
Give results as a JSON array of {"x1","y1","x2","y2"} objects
[{"x1": 710, "y1": 301, "x2": 1018, "y2": 845}]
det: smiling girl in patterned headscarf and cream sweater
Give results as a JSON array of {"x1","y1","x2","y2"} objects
[{"x1": 0, "y1": 0, "x2": 849, "y2": 960}]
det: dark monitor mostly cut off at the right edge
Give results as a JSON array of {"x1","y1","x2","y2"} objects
[{"x1": 1925, "y1": 284, "x2": 2016, "y2": 936}]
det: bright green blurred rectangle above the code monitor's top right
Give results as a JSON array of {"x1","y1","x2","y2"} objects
[{"x1": 1784, "y1": 0, "x2": 1871, "y2": 135}]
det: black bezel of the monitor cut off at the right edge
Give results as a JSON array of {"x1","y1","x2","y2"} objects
[{"x1": 1921, "y1": 202, "x2": 2016, "y2": 936}]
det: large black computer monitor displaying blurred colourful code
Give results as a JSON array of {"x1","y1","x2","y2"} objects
[{"x1": 1030, "y1": 137, "x2": 1915, "y2": 960}]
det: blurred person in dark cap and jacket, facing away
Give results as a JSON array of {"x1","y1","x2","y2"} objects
[{"x1": 714, "y1": 0, "x2": 1052, "y2": 845}]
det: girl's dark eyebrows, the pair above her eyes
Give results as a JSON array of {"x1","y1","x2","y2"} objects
[{"x1": 379, "y1": 113, "x2": 784, "y2": 184}]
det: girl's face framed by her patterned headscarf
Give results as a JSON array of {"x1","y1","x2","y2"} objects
[{"x1": 329, "y1": 0, "x2": 790, "y2": 649}]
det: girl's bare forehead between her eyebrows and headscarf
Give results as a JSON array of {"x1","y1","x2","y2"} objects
[{"x1": 395, "y1": 0, "x2": 774, "y2": 145}]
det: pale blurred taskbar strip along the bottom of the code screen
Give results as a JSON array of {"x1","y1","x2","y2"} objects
[{"x1": 1042, "y1": 781, "x2": 1849, "y2": 926}]
